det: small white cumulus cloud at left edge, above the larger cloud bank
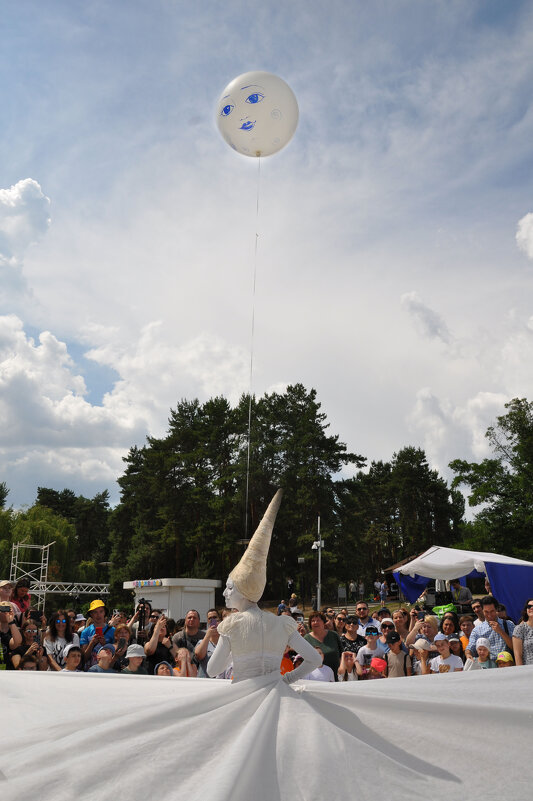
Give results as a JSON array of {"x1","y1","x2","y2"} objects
[{"x1": 0, "y1": 178, "x2": 50, "y2": 263}]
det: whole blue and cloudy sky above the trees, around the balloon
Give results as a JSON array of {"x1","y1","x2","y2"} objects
[{"x1": 0, "y1": 0, "x2": 533, "y2": 506}]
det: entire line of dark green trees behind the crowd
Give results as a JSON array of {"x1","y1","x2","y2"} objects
[{"x1": 0, "y1": 384, "x2": 533, "y2": 601}]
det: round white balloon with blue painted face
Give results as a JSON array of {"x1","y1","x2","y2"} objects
[{"x1": 217, "y1": 70, "x2": 298, "y2": 156}]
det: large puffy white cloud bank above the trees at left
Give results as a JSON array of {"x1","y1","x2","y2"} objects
[{"x1": 0, "y1": 315, "x2": 248, "y2": 502}]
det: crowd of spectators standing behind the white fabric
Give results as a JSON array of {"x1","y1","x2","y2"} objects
[{"x1": 0, "y1": 579, "x2": 533, "y2": 682}]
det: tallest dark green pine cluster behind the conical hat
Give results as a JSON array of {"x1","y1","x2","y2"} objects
[{"x1": 111, "y1": 384, "x2": 364, "y2": 593}]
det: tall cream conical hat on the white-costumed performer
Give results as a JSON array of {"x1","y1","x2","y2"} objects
[{"x1": 229, "y1": 489, "x2": 283, "y2": 603}]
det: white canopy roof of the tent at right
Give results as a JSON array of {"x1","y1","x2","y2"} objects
[{"x1": 399, "y1": 545, "x2": 533, "y2": 579}]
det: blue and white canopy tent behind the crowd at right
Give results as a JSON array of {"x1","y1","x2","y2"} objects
[{"x1": 394, "y1": 545, "x2": 533, "y2": 622}]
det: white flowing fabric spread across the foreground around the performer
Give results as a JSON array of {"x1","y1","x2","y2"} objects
[{"x1": 0, "y1": 666, "x2": 533, "y2": 801}]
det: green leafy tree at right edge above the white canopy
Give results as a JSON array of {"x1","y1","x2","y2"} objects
[{"x1": 450, "y1": 398, "x2": 533, "y2": 559}]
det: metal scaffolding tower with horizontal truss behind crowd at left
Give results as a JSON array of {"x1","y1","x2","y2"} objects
[{"x1": 9, "y1": 542, "x2": 109, "y2": 609}]
